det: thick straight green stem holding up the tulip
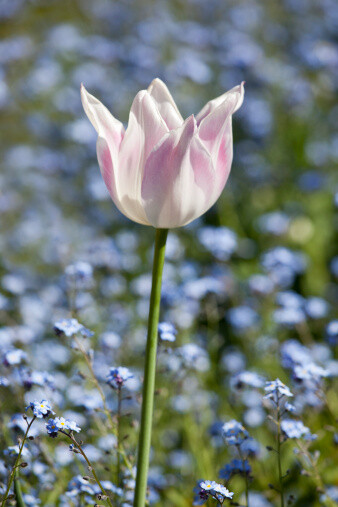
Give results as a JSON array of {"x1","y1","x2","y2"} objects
[{"x1": 134, "y1": 229, "x2": 168, "y2": 507}]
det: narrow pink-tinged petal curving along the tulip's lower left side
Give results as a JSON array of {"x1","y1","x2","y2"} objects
[{"x1": 96, "y1": 137, "x2": 150, "y2": 225}]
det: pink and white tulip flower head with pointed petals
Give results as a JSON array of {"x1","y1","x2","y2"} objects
[{"x1": 81, "y1": 79, "x2": 244, "y2": 229}]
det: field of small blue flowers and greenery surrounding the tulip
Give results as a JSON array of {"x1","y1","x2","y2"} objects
[{"x1": 0, "y1": 0, "x2": 338, "y2": 507}]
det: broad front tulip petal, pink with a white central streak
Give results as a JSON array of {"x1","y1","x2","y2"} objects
[{"x1": 142, "y1": 116, "x2": 215, "y2": 228}]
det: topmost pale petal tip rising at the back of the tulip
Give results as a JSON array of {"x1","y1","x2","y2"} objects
[{"x1": 148, "y1": 78, "x2": 183, "y2": 130}]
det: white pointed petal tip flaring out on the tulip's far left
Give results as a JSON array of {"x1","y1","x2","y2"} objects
[{"x1": 81, "y1": 85, "x2": 124, "y2": 159}]
